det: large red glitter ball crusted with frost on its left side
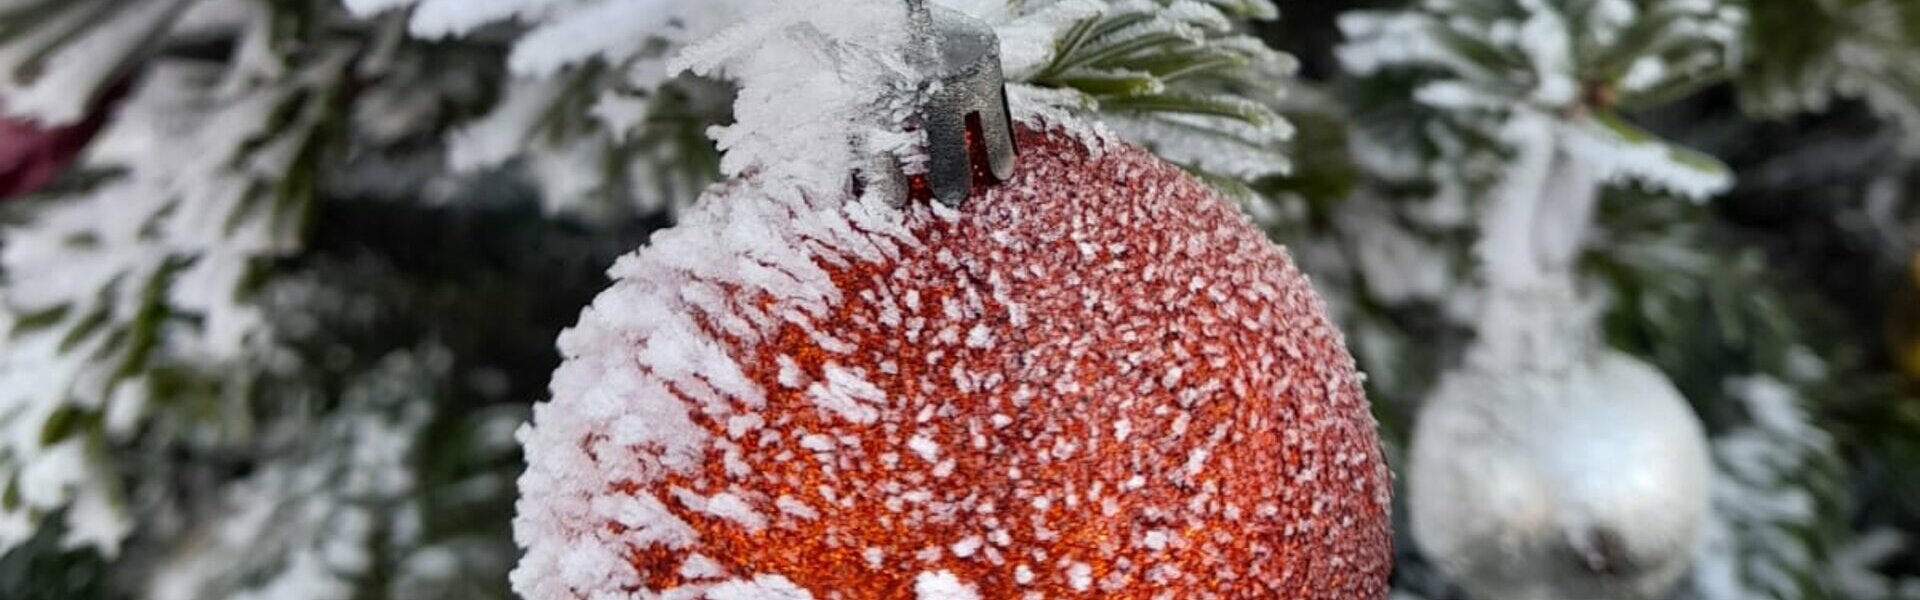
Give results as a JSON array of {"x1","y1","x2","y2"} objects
[{"x1": 513, "y1": 127, "x2": 1390, "y2": 600}]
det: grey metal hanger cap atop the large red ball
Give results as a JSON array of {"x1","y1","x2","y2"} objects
[{"x1": 906, "y1": 0, "x2": 1016, "y2": 206}]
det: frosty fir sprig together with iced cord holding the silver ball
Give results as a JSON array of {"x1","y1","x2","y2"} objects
[{"x1": 1338, "y1": 0, "x2": 1745, "y2": 311}]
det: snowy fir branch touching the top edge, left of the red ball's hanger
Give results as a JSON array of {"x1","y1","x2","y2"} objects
[{"x1": 346, "y1": 0, "x2": 764, "y2": 215}]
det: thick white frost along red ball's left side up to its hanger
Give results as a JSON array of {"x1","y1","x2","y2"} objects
[{"x1": 513, "y1": 2, "x2": 929, "y2": 598}]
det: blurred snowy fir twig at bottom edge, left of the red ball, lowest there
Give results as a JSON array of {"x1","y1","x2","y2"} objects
[{"x1": 148, "y1": 348, "x2": 439, "y2": 600}]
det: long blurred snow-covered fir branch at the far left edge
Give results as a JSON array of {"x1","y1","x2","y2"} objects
[{"x1": 0, "y1": 5, "x2": 353, "y2": 554}]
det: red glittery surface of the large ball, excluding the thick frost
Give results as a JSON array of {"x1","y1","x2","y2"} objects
[{"x1": 534, "y1": 131, "x2": 1392, "y2": 600}]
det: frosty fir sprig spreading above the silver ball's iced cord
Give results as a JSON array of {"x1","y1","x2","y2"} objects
[{"x1": 1338, "y1": 0, "x2": 1745, "y2": 198}]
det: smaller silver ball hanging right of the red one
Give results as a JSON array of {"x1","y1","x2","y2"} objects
[{"x1": 1407, "y1": 282, "x2": 1711, "y2": 600}]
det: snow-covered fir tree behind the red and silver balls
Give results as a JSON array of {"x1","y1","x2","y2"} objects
[{"x1": 0, "y1": 0, "x2": 1920, "y2": 600}]
